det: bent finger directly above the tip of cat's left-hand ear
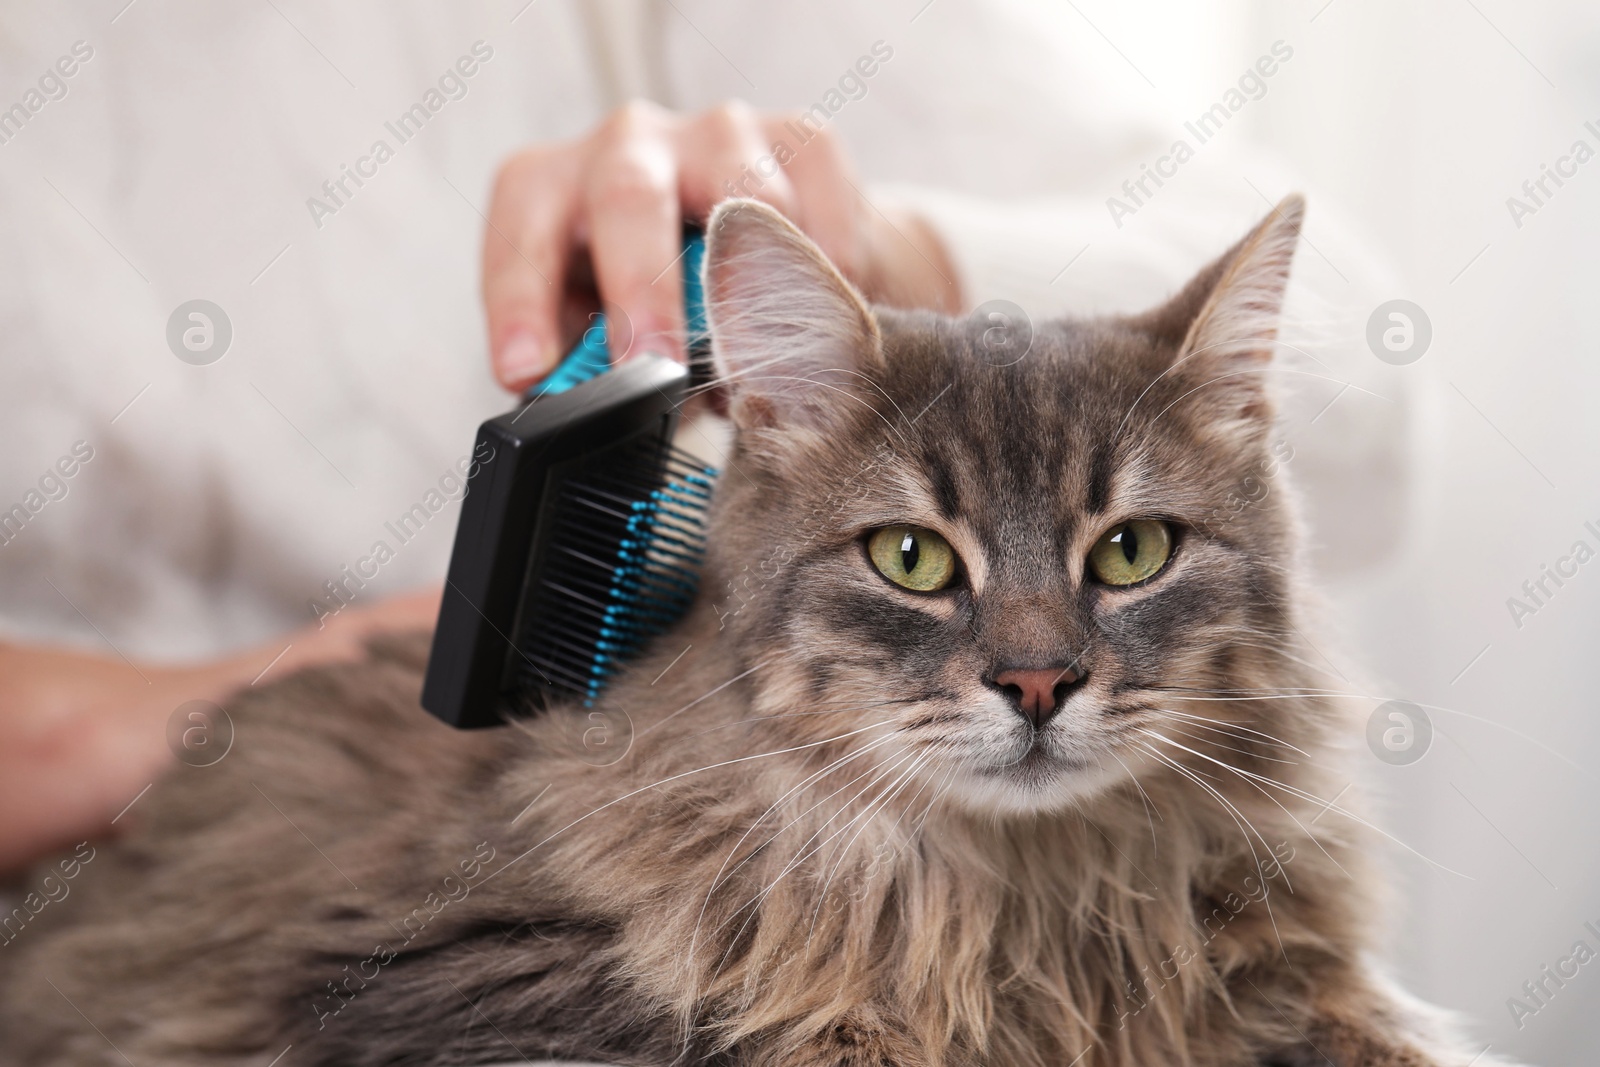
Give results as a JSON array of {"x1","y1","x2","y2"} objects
[{"x1": 678, "y1": 101, "x2": 798, "y2": 224}]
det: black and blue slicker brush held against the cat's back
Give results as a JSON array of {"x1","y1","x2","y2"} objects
[{"x1": 422, "y1": 234, "x2": 717, "y2": 728}]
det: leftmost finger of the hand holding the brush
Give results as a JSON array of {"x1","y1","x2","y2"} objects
[{"x1": 483, "y1": 146, "x2": 581, "y2": 392}]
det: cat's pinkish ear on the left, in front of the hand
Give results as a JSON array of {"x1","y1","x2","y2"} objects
[{"x1": 706, "y1": 200, "x2": 883, "y2": 429}]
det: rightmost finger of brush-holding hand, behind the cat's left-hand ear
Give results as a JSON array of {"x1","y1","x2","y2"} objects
[{"x1": 763, "y1": 115, "x2": 872, "y2": 285}]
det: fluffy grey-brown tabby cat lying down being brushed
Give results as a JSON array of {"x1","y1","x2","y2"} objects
[{"x1": 0, "y1": 197, "x2": 1510, "y2": 1067}]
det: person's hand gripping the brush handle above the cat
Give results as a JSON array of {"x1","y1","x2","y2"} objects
[{"x1": 483, "y1": 102, "x2": 960, "y2": 390}]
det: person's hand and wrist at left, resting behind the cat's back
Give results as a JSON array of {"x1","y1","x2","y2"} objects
[{"x1": 0, "y1": 589, "x2": 440, "y2": 875}]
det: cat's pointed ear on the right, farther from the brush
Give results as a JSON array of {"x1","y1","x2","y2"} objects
[{"x1": 1146, "y1": 194, "x2": 1306, "y2": 421}]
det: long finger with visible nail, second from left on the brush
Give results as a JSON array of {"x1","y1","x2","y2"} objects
[{"x1": 584, "y1": 104, "x2": 685, "y2": 362}]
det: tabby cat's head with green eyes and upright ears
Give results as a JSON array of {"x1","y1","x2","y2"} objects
[{"x1": 702, "y1": 197, "x2": 1304, "y2": 811}]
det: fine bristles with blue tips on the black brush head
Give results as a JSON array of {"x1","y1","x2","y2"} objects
[{"x1": 517, "y1": 440, "x2": 717, "y2": 707}]
